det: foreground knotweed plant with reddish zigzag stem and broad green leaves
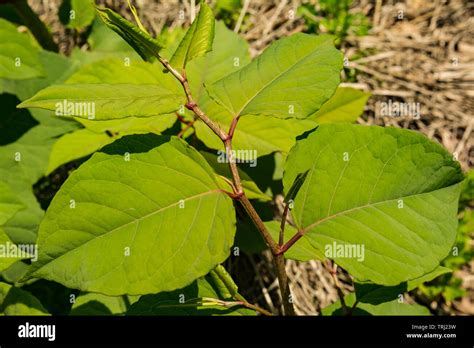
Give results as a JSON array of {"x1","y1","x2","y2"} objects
[{"x1": 14, "y1": 2, "x2": 463, "y2": 315}]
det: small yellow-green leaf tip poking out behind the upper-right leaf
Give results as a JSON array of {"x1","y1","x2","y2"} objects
[{"x1": 308, "y1": 87, "x2": 370, "y2": 124}]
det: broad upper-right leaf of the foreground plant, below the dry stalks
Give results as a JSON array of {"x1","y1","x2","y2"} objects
[{"x1": 209, "y1": 33, "x2": 342, "y2": 119}]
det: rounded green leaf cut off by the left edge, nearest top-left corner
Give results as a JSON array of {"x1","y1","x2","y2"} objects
[{"x1": 0, "y1": 18, "x2": 44, "y2": 80}]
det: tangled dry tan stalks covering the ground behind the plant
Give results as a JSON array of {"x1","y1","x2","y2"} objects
[{"x1": 29, "y1": 0, "x2": 474, "y2": 314}]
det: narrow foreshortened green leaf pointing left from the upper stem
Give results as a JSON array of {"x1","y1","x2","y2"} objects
[{"x1": 18, "y1": 84, "x2": 182, "y2": 121}]
